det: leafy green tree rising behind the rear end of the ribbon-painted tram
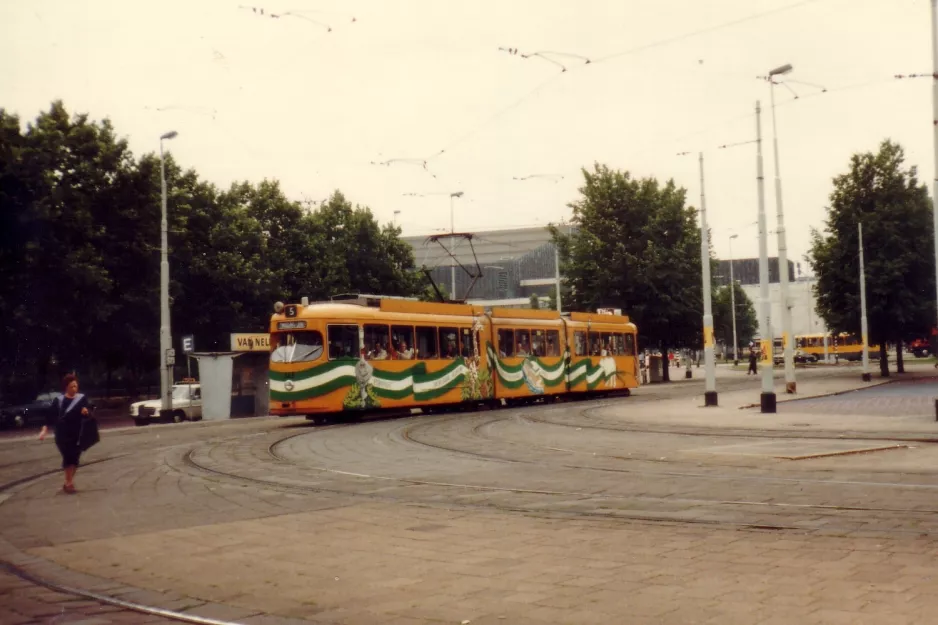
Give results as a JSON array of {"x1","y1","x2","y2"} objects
[{"x1": 552, "y1": 164, "x2": 703, "y2": 375}]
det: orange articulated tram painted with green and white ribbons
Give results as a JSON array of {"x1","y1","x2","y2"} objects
[{"x1": 270, "y1": 297, "x2": 639, "y2": 420}]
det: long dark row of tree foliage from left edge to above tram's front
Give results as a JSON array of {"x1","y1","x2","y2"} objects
[{"x1": 0, "y1": 101, "x2": 424, "y2": 395}]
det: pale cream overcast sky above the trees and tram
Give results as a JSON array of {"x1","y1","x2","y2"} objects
[{"x1": 0, "y1": 0, "x2": 934, "y2": 268}]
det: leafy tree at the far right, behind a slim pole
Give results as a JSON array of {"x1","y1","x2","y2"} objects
[{"x1": 807, "y1": 140, "x2": 935, "y2": 377}]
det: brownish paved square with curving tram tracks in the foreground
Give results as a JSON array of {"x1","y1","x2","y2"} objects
[{"x1": 0, "y1": 369, "x2": 938, "y2": 625}]
